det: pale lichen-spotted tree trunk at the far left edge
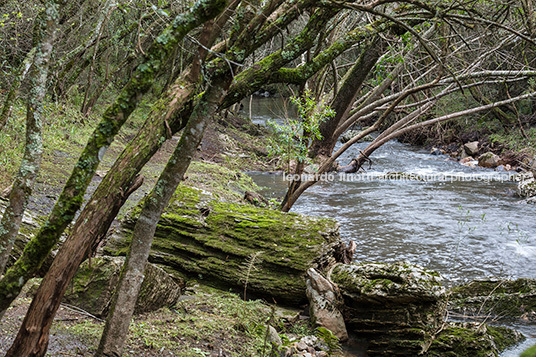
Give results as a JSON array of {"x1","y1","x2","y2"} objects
[{"x1": 0, "y1": 1, "x2": 59, "y2": 276}]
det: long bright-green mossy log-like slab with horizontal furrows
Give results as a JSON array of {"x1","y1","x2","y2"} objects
[{"x1": 105, "y1": 185, "x2": 342, "y2": 305}]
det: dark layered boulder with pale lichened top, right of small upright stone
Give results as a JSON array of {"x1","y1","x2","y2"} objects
[{"x1": 330, "y1": 263, "x2": 446, "y2": 356}]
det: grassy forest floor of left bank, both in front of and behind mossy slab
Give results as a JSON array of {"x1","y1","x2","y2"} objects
[{"x1": 0, "y1": 96, "x2": 314, "y2": 357}]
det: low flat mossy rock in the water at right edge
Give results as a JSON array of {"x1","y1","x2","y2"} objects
[{"x1": 449, "y1": 278, "x2": 536, "y2": 321}]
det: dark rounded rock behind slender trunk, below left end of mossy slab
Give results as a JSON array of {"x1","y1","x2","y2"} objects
[{"x1": 64, "y1": 257, "x2": 181, "y2": 317}]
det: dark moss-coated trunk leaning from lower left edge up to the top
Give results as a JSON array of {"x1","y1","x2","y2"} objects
[{"x1": 0, "y1": 0, "x2": 225, "y2": 320}]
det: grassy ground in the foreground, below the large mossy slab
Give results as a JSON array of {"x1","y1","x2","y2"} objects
[{"x1": 0, "y1": 286, "x2": 314, "y2": 357}]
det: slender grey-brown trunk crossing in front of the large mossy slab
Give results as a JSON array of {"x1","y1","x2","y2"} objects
[{"x1": 96, "y1": 79, "x2": 223, "y2": 356}]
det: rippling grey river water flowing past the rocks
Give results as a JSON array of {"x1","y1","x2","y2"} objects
[{"x1": 245, "y1": 98, "x2": 536, "y2": 356}]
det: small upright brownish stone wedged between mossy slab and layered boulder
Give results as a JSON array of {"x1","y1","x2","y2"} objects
[{"x1": 305, "y1": 268, "x2": 348, "y2": 342}]
